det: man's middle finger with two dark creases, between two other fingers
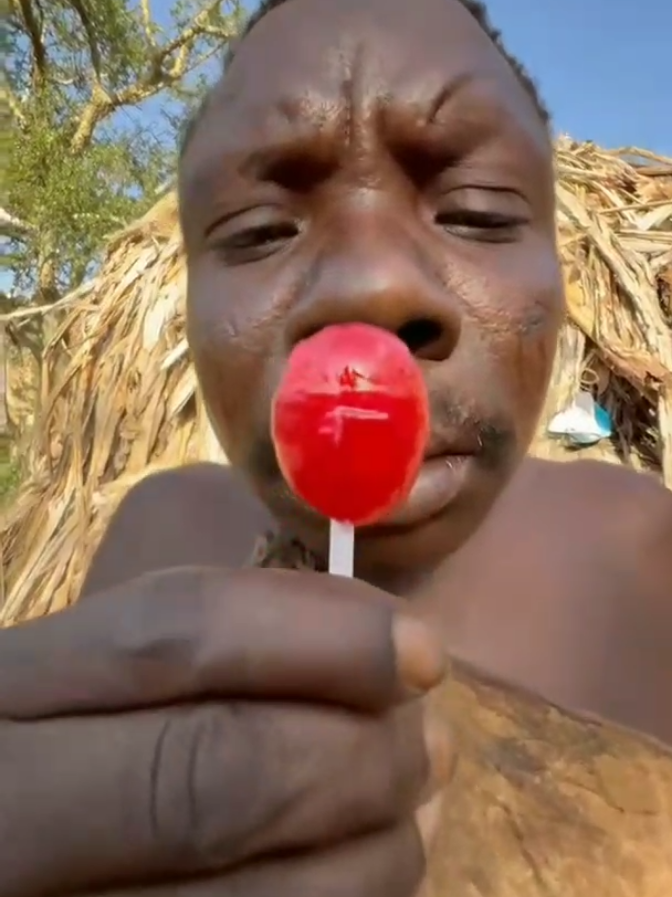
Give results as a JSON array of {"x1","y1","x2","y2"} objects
[{"x1": 0, "y1": 702, "x2": 447, "y2": 895}]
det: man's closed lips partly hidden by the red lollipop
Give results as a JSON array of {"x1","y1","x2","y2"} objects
[{"x1": 365, "y1": 453, "x2": 477, "y2": 534}]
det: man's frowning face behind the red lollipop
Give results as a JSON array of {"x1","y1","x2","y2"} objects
[{"x1": 180, "y1": 0, "x2": 563, "y2": 570}]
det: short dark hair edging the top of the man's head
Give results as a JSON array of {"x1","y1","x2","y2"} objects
[{"x1": 179, "y1": 0, "x2": 551, "y2": 158}]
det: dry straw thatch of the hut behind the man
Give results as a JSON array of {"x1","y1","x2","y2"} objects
[{"x1": 0, "y1": 139, "x2": 672, "y2": 622}]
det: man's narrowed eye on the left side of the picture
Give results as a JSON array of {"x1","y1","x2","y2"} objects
[{"x1": 212, "y1": 209, "x2": 300, "y2": 265}]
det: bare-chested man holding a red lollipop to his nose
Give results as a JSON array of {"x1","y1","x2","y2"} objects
[{"x1": 0, "y1": 0, "x2": 672, "y2": 897}]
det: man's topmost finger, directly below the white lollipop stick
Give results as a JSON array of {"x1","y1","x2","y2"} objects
[{"x1": 0, "y1": 569, "x2": 444, "y2": 719}]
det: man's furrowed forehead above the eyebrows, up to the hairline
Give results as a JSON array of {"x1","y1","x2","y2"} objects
[{"x1": 182, "y1": 0, "x2": 549, "y2": 178}]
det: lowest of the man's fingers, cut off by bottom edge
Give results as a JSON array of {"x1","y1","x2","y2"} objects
[{"x1": 86, "y1": 823, "x2": 425, "y2": 897}]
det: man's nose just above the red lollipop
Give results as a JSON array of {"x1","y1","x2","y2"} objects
[{"x1": 286, "y1": 209, "x2": 461, "y2": 361}]
